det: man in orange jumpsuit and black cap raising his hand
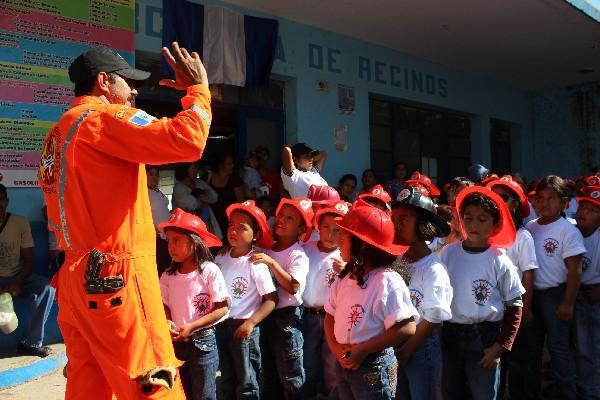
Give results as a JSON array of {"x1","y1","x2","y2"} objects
[{"x1": 39, "y1": 43, "x2": 211, "y2": 400}]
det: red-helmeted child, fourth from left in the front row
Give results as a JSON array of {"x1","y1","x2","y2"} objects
[{"x1": 302, "y1": 201, "x2": 350, "y2": 399}]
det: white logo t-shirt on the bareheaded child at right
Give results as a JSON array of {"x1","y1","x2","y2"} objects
[{"x1": 526, "y1": 218, "x2": 586, "y2": 289}]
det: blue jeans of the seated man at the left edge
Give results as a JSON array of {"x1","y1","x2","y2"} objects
[{"x1": 0, "y1": 274, "x2": 56, "y2": 347}]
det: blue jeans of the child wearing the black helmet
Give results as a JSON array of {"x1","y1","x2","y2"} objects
[{"x1": 396, "y1": 331, "x2": 442, "y2": 400}]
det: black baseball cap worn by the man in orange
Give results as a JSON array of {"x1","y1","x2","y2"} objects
[{"x1": 69, "y1": 47, "x2": 150, "y2": 83}]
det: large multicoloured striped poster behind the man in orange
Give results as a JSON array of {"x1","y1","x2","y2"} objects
[{"x1": 0, "y1": 0, "x2": 135, "y2": 187}]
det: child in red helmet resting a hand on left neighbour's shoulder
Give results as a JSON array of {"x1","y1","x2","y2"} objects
[{"x1": 250, "y1": 197, "x2": 313, "y2": 399}]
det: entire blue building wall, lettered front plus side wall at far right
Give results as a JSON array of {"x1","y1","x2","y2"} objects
[{"x1": 14, "y1": 0, "x2": 600, "y2": 238}]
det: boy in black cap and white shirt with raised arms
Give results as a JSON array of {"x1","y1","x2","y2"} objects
[{"x1": 281, "y1": 143, "x2": 328, "y2": 198}]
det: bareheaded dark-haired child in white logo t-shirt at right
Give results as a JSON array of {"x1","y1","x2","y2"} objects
[{"x1": 526, "y1": 175, "x2": 586, "y2": 400}]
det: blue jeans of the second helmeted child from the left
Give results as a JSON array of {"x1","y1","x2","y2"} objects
[{"x1": 217, "y1": 319, "x2": 260, "y2": 400}]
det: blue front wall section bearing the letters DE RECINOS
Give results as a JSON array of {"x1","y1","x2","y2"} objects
[{"x1": 136, "y1": 0, "x2": 531, "y2": 184}]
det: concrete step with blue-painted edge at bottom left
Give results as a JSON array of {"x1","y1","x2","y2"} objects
[{"x1": 0, "y1": 343, "x2": 67, "y2": 390}]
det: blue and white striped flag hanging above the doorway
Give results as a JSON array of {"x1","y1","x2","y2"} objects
[{"x1": 163, "y1": 0, "x2": 279, "y2": 86}]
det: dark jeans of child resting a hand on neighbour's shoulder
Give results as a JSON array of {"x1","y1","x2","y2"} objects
[{"x1": 260, "y1": 307, "x2": 305, "y2": 400}]
